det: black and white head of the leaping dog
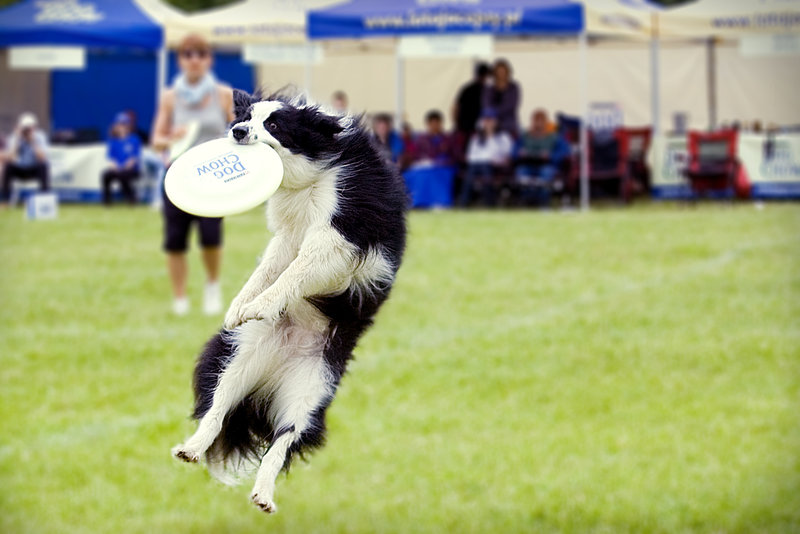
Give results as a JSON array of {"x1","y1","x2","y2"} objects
[{"x1": 228, "y1": 90, "x2": 344, "y2": 170}]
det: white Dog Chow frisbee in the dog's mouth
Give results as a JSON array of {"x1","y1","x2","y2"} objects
[{"x1": 164, "y1": 138, "x2": 283, "y2": 217}]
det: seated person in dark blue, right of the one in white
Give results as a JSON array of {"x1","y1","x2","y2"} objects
[{"x1": 514, "y1": 108, "x2": 569, "y2": 205}]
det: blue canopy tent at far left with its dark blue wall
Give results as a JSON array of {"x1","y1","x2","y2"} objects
[{"x1": 0, "y1": 0, "x2": 166, "y2": 137}]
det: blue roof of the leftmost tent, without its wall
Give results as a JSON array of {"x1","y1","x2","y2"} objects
[{"x1": 0, "y1": 0, "x2": 163, "y2": 49}]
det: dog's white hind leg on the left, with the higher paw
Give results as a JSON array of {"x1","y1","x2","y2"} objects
[{"x1": 172, "y1": 322, "x2": 277, "y2": 462}]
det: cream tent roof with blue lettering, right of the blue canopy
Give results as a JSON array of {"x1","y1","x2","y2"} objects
[{"x1": 585, "y1": 0, "x2": 800, "y2": 38}]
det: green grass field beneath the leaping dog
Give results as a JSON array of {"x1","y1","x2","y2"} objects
[{"x1": 0, "y1": 204, "x2": 800, "y2": 533}]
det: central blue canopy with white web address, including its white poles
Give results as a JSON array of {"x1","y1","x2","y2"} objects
[{"x1": 306, "y1": 0, "x2": 589, "y2": 209}]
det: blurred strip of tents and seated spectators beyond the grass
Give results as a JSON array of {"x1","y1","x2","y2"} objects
[{"x1": 0, "y1": 0, "x2": 800, "y2": 214}]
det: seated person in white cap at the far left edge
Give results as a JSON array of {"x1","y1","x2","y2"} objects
[{"x1": 0, "y1": 113, "x2": 50, "y2": 206}]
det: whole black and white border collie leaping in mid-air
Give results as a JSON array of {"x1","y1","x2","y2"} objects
[{"x1": 172, "y1": 91, "x2": 407, "y2": 512}]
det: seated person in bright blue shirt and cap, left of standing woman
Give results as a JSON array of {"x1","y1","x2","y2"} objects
[{"x1": 103, "y1": 112, "x2": 142, "y2": 206}]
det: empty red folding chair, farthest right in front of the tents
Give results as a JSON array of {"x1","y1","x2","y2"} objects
[{"x1": 684, "y1": 130, "x2": 739, "y2": 197}]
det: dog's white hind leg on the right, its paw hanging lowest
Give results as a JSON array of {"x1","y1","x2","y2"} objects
[{"x1": 250, "y1": 355, "x2": 335, "y2": 513}]
